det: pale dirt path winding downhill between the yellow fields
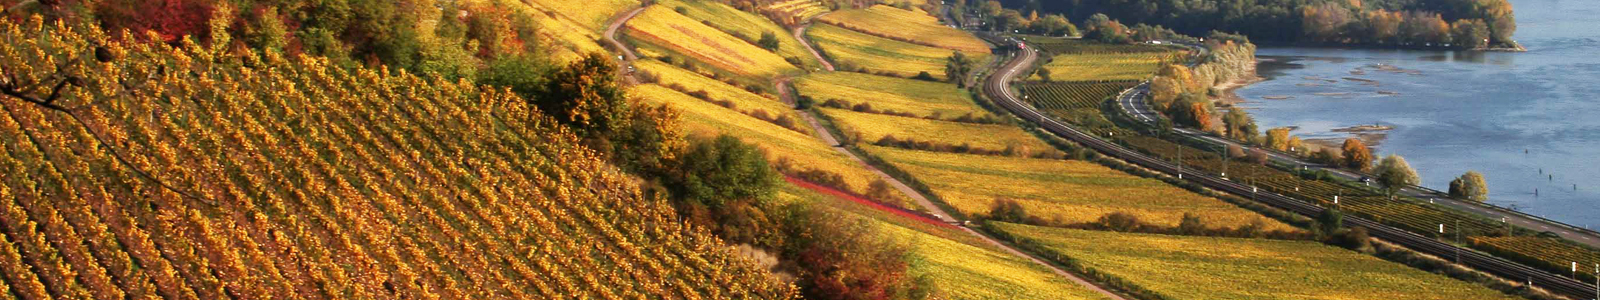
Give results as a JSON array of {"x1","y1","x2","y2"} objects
[{"x1": 605, "y1": 8, "x2": 1128, "y2": 300}]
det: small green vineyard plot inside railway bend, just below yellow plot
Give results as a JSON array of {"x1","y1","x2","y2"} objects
[{"x1": 1018, "y1": 80, "x2": 1139, "y2": 110}]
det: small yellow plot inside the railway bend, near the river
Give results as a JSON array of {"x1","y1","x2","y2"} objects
[{"x1": 1034, "y1": 51, "x2": 1181, "y2": 81}]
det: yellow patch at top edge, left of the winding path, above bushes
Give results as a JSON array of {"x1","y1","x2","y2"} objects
[{"x1": 502, "y1": 0, "x2": 638, "y2": 61}]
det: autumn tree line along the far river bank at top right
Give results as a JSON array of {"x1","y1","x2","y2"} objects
[{"x1": 1003, "y1": 0, "x2": 1517, "y2": 49}]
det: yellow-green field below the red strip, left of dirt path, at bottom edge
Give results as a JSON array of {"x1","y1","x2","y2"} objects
[{"x1": 779, "y1": 185, "x2": 1104, "y2": 300}]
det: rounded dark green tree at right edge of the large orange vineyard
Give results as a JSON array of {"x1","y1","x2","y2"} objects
[{"x1": 664, "y1": 136, "x2": 779, "y2": 209}]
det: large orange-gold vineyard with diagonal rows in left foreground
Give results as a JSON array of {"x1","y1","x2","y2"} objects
[{"x1": 0, "y1": 18, "x2": 795, "y2": 298}]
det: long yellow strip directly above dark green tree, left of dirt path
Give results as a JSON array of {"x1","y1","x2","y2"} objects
[{"x1": 629, "y1": 85, "x2": 883, "y2": 201}]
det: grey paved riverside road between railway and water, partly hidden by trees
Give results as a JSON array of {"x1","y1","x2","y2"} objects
[{"x1": 1117, "y1": 43, "x2": 1600, "y2": 247}]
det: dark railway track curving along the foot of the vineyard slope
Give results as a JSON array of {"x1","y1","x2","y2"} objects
[{"x1": 984, "y1": 43, "x2": 1595, "y2": 298}]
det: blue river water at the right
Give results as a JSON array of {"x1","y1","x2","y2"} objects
[{"x1": 1237, "y1": 0, "x2": 1600, "y2": 228}]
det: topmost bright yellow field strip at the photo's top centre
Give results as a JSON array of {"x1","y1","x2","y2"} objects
[{"x1": 818, "y1": 5, "x2": 989, "y2": 54}]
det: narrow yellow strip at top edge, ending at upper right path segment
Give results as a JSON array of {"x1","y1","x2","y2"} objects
[{"x1": 656, "y1": 0, "x2": 822, "y2": 69}]
